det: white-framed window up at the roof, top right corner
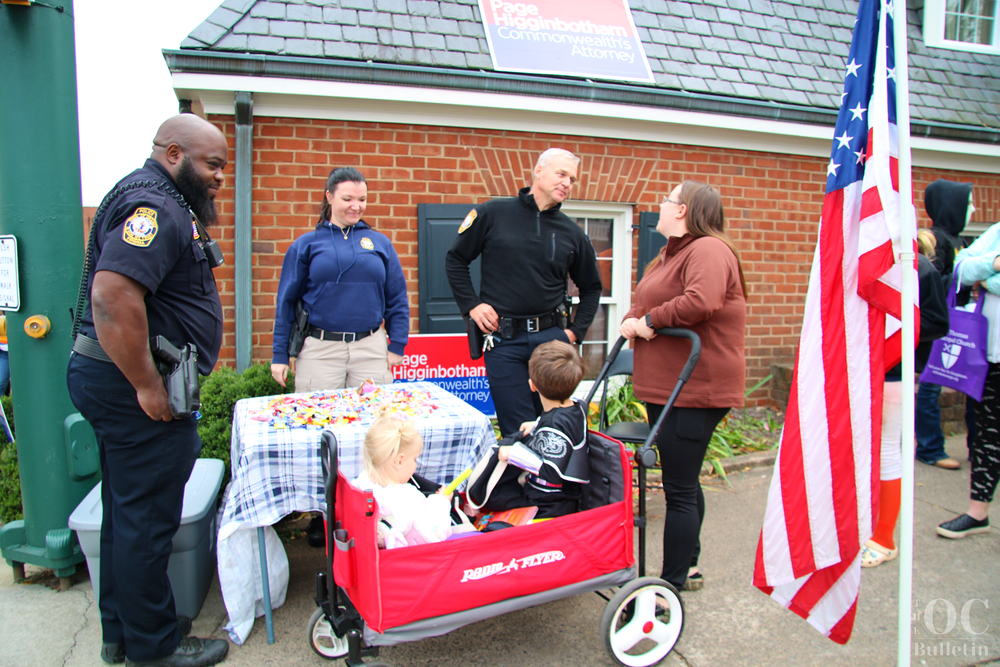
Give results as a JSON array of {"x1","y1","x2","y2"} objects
[{"x1": 924, "y1": 0, "x2": 1000, "y2": 54}]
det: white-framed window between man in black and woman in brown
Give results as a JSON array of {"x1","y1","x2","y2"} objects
[{"x1": 562, "y1": 201, "x2": 632, "y2": 384}]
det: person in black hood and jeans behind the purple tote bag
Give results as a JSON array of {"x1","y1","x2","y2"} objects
[{"x1": 914, "y1": 178, "x2": 976, "y2": 470}]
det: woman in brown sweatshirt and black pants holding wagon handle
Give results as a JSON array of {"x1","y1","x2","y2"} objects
[{"x1": 619, "y1": 181, "x2": 746, "y2": 590}]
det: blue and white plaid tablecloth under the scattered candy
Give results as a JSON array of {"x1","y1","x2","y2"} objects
[{"x1": 220, "y1": 382, "x2": 496, "y2": 528}]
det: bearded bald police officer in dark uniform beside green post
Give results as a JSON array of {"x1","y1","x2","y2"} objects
[{"x1": 67, "y1": 114, "x2": 229, "y2": 667}]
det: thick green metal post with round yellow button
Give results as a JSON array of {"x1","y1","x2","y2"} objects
[{"x1": 0, "y1": 0, "x2": 100, "y2": 585}]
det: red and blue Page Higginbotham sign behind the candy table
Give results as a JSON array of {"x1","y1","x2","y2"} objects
[{"x1": 392, "y1": 334, "x2": 496, "y2": 417}]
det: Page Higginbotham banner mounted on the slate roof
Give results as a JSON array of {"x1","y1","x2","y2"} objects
[{"x1": 479, "y1": 0, "x2": 654, "y2": 83}]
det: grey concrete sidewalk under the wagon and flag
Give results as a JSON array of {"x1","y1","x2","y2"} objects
[{"x1": 0, "y1": 435, "x2": 1000, "y2": 667}]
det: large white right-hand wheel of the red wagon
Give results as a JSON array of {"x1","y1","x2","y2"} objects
[{"x1": 601, "y1": 577, "x2": 684, "y2": 667}]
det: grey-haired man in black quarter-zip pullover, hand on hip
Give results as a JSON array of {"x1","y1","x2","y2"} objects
[{"x1": 445, "y1": 148, "x2": 602, "y2": 436}]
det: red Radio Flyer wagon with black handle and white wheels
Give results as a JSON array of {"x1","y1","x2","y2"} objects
[{"x1": 308, "y1": 329, "x2": 701, "y2": 667}]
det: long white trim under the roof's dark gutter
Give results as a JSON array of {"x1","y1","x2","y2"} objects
[{"x1": 172, "y1": 72, "x2": 1000, "y2": 173}]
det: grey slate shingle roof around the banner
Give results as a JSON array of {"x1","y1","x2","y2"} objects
[{"x1": 181, "y1": 0, "x2": 1000, "y2": 128}]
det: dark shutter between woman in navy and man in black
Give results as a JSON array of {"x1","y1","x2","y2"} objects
[{"x1": 417, "y1": 202, "x2": 481, "y2": 333}]
